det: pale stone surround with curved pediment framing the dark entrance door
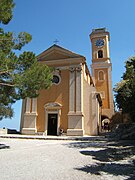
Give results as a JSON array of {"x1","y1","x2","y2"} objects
[{"x1": 44, "y1": 102, "x2": 62, "y2": 136}]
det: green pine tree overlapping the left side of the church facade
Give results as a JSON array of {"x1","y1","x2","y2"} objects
[{"x1": 0, "y1": 0, "x2": 52, "y2": 119}]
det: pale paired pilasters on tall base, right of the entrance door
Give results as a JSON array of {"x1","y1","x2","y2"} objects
[{"x1": 67, "y1": 66, "x2": 84, "y2": 136}]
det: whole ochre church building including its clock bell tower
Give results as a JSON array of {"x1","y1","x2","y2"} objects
[{"x1": 20, "y1": 28, "x2": 114, "y2": 136}]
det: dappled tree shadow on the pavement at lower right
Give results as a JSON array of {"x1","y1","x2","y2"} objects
[{"x1": 68, "y1": 140, "x2": 135, "y2": 180}]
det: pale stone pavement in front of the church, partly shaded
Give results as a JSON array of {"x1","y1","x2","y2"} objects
[{"x1": 0, "y1": 135, "x2": 135, "y2": 180}]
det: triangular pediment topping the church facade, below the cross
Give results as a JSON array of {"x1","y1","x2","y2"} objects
[{"x1": 37, "y1": 45, "x2": 84, "y2": 61}]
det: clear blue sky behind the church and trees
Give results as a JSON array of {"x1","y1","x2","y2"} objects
[{"x1": 0, "y1": 0, "x2": 135, "y2": 130}]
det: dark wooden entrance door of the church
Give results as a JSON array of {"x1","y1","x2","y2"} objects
[{"x1": 47, "y1": 114, "x2": 58, "y2": 135}]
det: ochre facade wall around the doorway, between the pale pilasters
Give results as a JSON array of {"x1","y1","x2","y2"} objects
[{"x1": 37, "y1": 70, "x2": 69, "y2": 132}]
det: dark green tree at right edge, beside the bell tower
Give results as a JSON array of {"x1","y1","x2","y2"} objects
[{"x1": 114, "y1": 57, "x2": 135, "y2": 121}]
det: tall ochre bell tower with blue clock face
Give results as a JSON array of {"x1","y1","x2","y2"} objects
[{"x1": 90, "y1": 28, "x2": 114, "y2": 120}]
